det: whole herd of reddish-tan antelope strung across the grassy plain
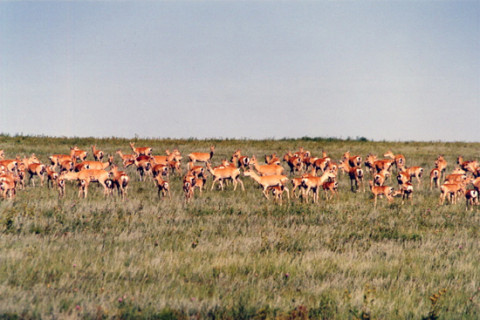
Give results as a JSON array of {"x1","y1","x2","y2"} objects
[{"x1": 0, "y1": 143, "x2": 480, "y2": 209}]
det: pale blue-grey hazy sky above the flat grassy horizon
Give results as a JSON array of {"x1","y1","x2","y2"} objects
[{"x1": 0, "y1": 0, "x2": 480, "y2": 142}]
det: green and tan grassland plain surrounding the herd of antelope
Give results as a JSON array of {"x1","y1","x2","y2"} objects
[{"x1": 0, "y1": 135, "x2": 480, "y2": 319}]
